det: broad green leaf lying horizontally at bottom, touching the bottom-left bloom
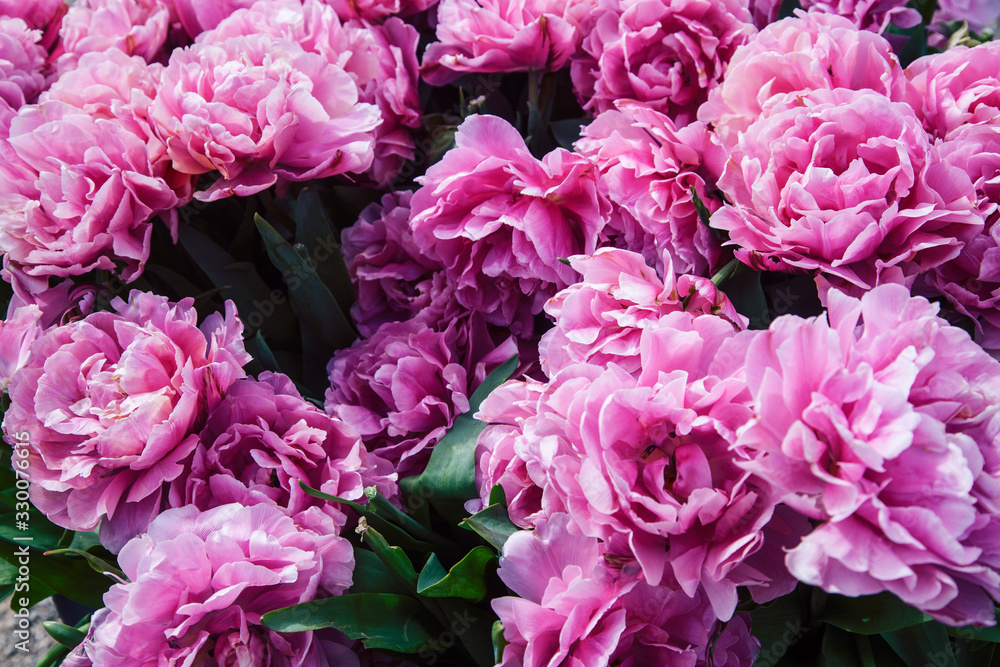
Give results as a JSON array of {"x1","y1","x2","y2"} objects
[{"x1": 262, "y1": 593, "x2": 441, "y2": 653}]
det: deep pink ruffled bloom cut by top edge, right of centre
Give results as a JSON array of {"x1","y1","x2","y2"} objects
[{"x1": 572, "y1": 0, "x2": 757, "y2": 126}]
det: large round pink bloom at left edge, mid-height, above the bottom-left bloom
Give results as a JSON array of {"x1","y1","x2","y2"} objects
[{"x1": 4, "y1": 291, "x2": 250, "y2": 548}]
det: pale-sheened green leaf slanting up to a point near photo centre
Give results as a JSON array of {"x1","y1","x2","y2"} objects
[{"x1": 412, "y1": 356, "x2": 517, "y2": 523}]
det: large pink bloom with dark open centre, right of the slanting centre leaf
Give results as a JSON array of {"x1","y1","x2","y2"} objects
[{"x1": 480, "y1": 318, "x2": 794, "y2": 620}]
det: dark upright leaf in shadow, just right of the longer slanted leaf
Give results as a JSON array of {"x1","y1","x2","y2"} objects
[{"x1": 292, "y1": 188, "x2": 354, "y2": 313}]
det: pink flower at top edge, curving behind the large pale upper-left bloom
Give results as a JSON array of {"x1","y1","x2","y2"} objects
[{"x1": 198, "y1": 0, "x2": 421, "y2": 187}]
